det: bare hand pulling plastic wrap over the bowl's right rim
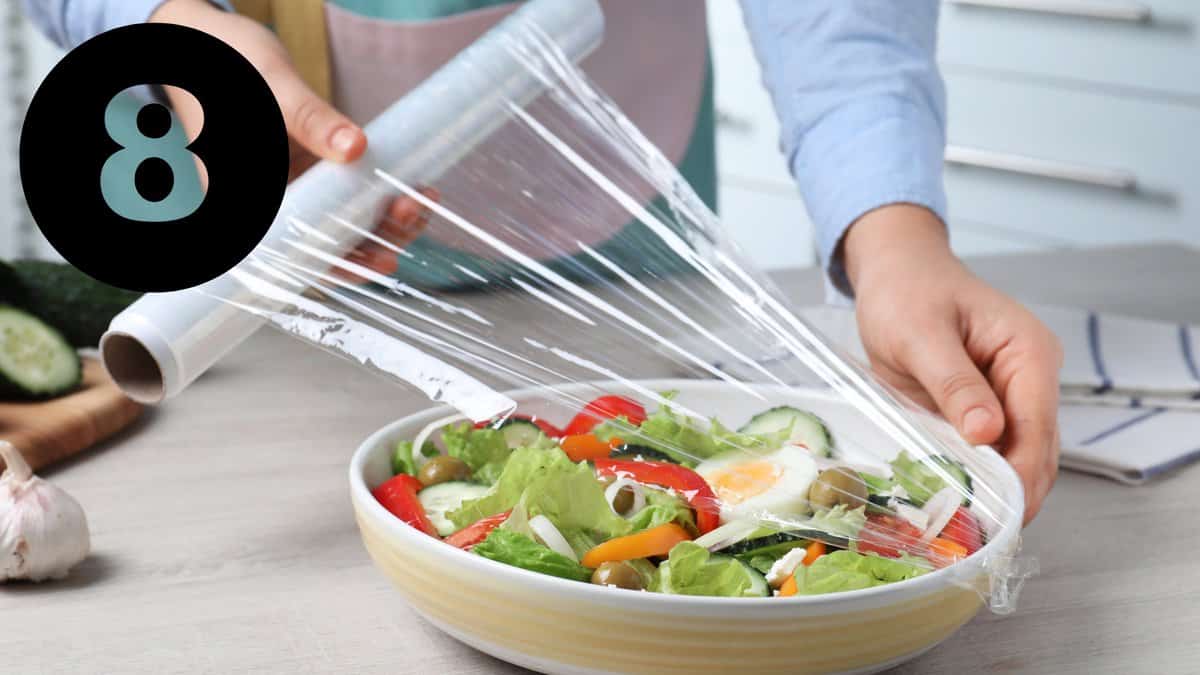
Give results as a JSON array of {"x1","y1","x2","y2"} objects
[{"x1": 841, "y1": 204, "x2": 1062, "y2": 522}]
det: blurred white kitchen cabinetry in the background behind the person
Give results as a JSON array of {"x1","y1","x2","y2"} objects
[{"x1": 0, "y1": 0, "x2": 1200, "y2": 269}]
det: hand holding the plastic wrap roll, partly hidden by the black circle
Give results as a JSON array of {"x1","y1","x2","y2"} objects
[{"x1": 150, "y1": 0, "x2": 425, "y2": 274}]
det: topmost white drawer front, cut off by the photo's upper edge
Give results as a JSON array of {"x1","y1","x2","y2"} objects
[{"x1": 940, "y1": 0, "x2": 1200, "y2": 96}]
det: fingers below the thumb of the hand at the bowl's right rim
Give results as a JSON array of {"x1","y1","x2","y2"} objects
[{"x1": 998, "y1": 327, "x2": 1060, "y2": 524}]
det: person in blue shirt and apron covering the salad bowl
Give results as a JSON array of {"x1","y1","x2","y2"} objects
[{"x1": 25, "y1": 0, "x2": 1062, "y2": 521}]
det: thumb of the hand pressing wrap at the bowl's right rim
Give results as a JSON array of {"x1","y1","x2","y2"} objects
[{"x1": 901, "y1": 328, "x2": 1004, "y2": 443}]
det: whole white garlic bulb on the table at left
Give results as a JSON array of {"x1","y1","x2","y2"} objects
[{"x1": 0, "y1": 441, "x2": 91, "y2": 581}]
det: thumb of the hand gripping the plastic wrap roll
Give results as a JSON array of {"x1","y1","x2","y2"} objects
[{"x1": 270, "y1": 65, "x2": 367, "y2": 162}]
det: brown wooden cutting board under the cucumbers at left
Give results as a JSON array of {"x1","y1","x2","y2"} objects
[{"x1": 0, "y1": 359, "x2": 142, "y2": 471}]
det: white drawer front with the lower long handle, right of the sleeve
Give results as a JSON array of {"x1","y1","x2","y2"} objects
[{"x1": 946, "y1": 74, "x2": 1200, "y2": 244}]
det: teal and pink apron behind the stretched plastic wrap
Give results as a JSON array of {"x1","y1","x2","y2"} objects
[{"x1": 238, "y1": 0, "x2": 715, "y2": 288}]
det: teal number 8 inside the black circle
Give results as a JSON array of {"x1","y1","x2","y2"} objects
[{"x1": 100, "y1": 94, "x2": 204, "y2": 222}]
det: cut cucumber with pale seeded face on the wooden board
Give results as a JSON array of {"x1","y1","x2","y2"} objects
[{"x1": 0, "y1": 306, "x2": 83, "y2": 400}]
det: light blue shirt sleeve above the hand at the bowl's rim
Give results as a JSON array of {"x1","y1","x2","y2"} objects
[{"x1": 742, "y1": 0, "x2": 947, "y2": 295}]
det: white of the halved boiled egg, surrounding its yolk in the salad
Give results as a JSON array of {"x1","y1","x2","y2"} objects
[{"x1": 696, "y1": 446, "x2": 817, "y2": 522}]
